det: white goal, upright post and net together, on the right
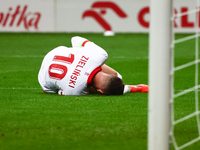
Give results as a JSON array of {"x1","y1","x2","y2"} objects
[{"x1": 148, "y1": 0, "x2": 200, "y2": 150}]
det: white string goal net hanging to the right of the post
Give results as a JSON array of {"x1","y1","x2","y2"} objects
[{"x1": 170, "y1": 0, "x2": 200, "y2": 150}]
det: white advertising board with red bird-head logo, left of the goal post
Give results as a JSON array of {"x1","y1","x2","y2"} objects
[{"x1": 57, "y1": 0, "x2": 149, "y2": 32}]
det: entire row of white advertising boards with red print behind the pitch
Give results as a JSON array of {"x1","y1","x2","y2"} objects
[{"x1": 0, "y1": 0, "x2": 197, "y2": 33}]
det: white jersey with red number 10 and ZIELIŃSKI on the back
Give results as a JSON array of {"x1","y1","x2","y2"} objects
[{"x1": 38, "y1": 37, "x2": 108, "y2": 95}]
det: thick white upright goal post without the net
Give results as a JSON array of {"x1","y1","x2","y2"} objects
[{"x1": 148, "y1": 0, "x2": 173, "y2": 150}]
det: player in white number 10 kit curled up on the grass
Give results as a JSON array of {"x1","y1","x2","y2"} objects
[{"x1": 38, "y1": 36, "x2": 149, "y2": 95}]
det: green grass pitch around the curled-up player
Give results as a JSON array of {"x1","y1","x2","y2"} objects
[{"x1": 0, "y1": 33, "x2": 200, "y2": 150}]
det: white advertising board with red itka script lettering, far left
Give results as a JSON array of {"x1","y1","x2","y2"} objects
[{"x1": 0, "y1": 0, "x2": 55, "y2": 32}]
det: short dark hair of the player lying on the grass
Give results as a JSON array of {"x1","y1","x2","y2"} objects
[{"x1": 104, "y1": 75, "x2": 124, "y2": 95}]
